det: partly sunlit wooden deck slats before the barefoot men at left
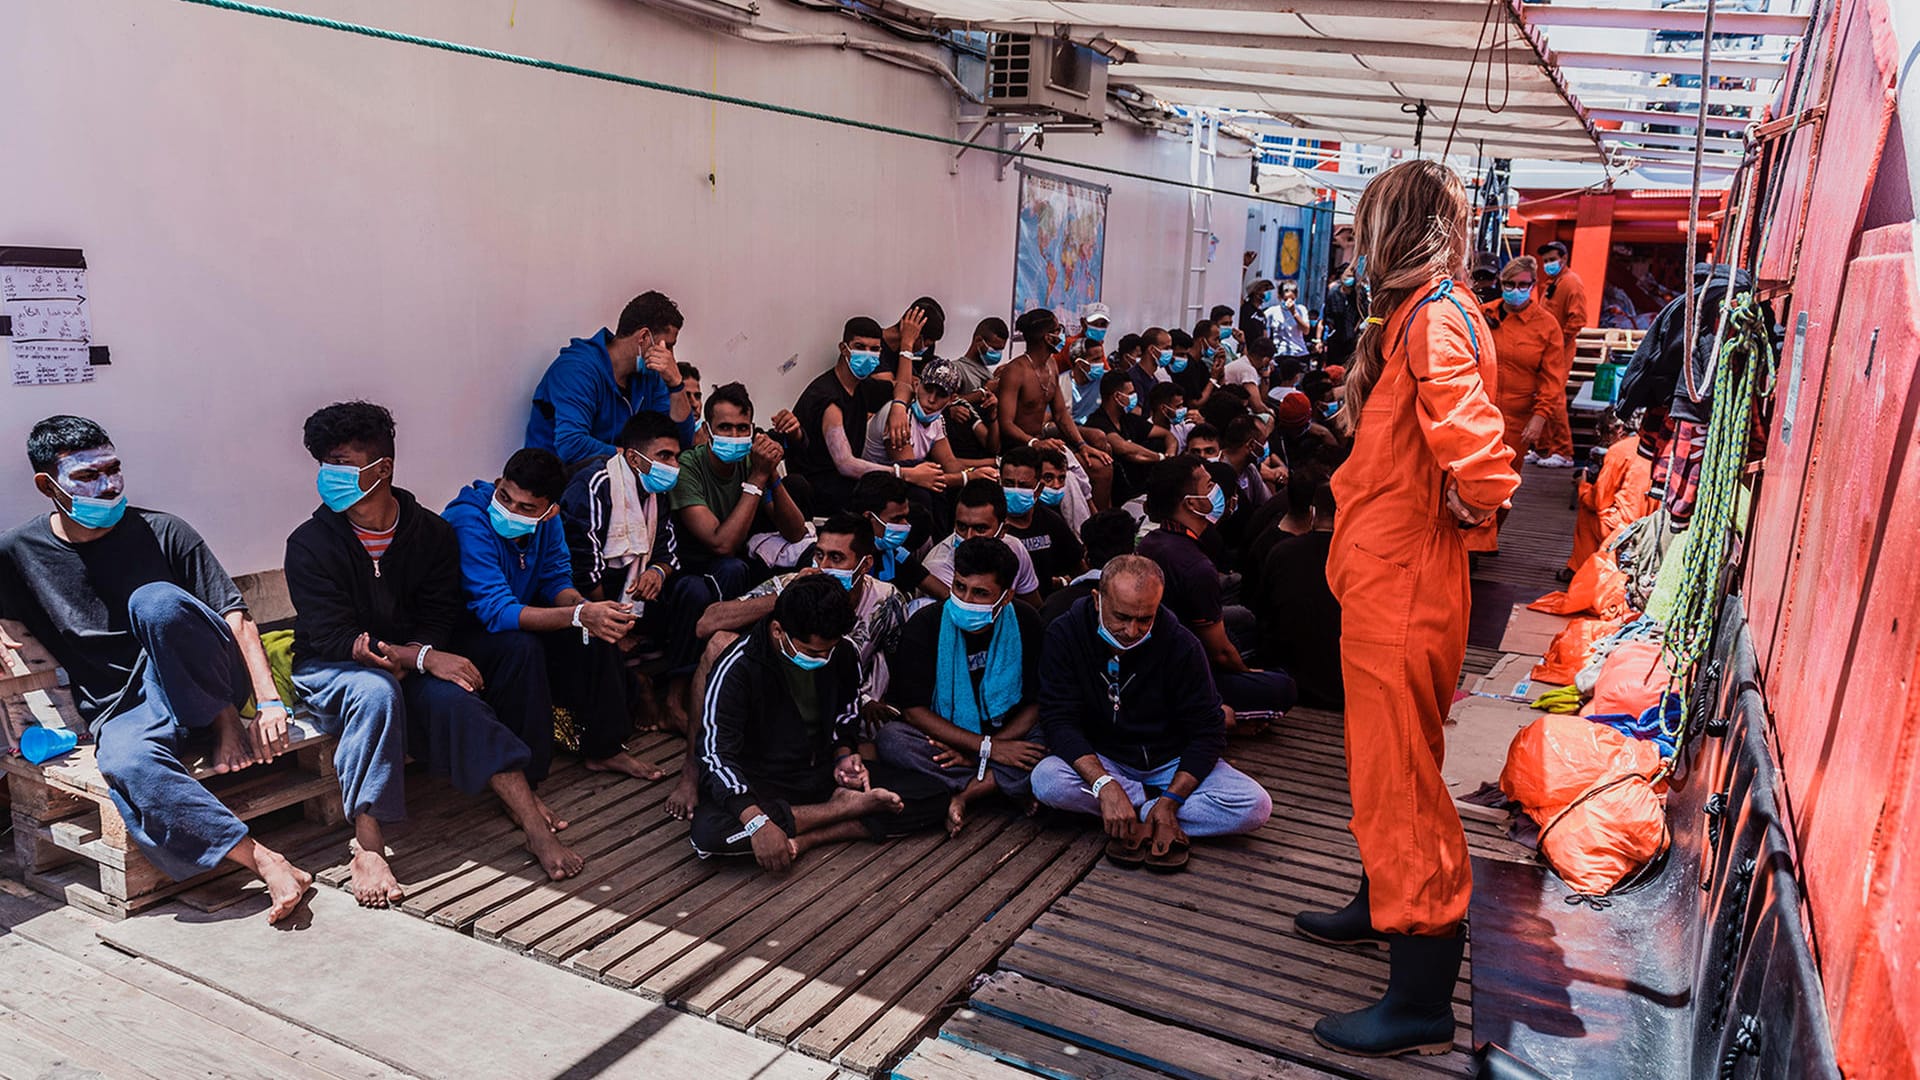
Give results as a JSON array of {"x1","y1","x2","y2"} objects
[{"x1": 259, "y1": 734, "x2": 1098, "y2": 1076}]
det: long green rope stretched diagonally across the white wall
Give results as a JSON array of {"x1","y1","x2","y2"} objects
[{"x1": 180, "y1": 0, "x2": 1313, "y2": 209}]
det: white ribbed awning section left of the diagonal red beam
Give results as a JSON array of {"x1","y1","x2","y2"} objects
[{"x1": 904, "y1": 0, "x2": 1601, "y2": 161}]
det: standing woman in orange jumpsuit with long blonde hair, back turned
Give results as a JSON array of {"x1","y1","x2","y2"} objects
[{"x1": 1294, "y1": 161, "x2": 1521, "y2": 1057}]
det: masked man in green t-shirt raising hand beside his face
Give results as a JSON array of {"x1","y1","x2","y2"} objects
[{"x1": 672, "y1": 382, "x2": 806, "y2": 600}]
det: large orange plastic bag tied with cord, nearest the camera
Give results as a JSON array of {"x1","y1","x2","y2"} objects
[{"x1": 1500, "y1": 713, "x2": 1668, "y2": 896}]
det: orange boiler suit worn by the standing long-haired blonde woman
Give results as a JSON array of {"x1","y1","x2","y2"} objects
[{"x1": 1327, "y1": 279, "x2": 1521, "y2": 934}]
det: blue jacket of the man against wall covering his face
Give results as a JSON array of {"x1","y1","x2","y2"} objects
[{"x1": 529, "y1": 327, "x2": 693, "y2": 463}]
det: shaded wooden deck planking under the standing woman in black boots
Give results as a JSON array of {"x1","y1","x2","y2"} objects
[{"x1": 944, "y1": 457, "x2": 1572, "y2": 1080}]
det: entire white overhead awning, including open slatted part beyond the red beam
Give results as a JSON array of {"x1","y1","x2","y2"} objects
[{"x1": 874, "y1": 0, "x2": 1807, "y2": 181}]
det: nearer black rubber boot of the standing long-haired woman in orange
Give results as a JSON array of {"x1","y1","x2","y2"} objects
[{"x1": 1313, "y1": 934, "x2": 1467, "y2": 1057}]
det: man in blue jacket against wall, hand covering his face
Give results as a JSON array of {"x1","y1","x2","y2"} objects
[{"x1": 526, "y1": 290, "x2": 695, "y2": 465}]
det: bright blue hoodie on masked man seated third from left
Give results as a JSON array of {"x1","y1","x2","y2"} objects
[{"x1": 440, "y1": 480, "x2": 574, "y2": 634}]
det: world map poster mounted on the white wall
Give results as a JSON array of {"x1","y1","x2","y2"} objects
[{"x1": 1014, "y1": 169, "x2": 1110, "y2": 327}]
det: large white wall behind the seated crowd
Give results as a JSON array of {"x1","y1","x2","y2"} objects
[{"x1": 0, "y1": 0, "x2": 1246, "y2": 573}]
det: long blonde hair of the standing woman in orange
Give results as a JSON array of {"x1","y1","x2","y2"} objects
[{"x1": 1338, "y1": 160, "x2": 1469, "y2": 430}]
